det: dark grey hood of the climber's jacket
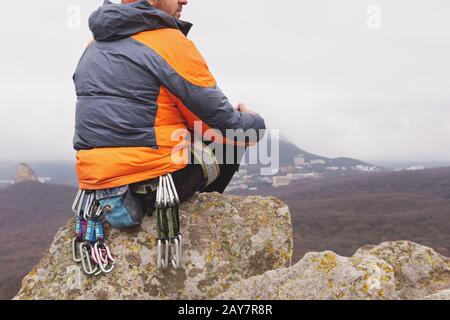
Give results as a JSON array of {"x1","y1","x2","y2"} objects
[{"x1": 89, "y1": 0, "x2": 192, "y2": 41}]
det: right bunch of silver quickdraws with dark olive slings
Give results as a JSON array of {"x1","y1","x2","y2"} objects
[{"x1": 153, "y1": 174, "x2": 182, "y2": 269}]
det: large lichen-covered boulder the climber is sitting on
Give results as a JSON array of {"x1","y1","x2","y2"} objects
[{"x1": 14, "y1": 193, "x2": 293, "y2": 299}]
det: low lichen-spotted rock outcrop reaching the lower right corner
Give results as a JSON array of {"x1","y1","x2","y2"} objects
[{"x1": 217, "y1": 241, "x2": 450, "y2": 300}]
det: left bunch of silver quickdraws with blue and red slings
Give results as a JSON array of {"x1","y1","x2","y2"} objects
[{"x1": 72, "y1": 190, "x2": 116, "y2": 275}]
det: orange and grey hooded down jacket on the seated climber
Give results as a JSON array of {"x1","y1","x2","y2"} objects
[{"x1": 73, "y1": 0, "x2": 265, "y2": 190}]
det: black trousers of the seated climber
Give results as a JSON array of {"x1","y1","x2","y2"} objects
[{"x1": 135, "y1": 145, "x2": 246, "y2": 215}]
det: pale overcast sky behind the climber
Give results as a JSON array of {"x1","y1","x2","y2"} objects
[{"x1": 0, "y1": 0, "x2": 450, "y2": 161}]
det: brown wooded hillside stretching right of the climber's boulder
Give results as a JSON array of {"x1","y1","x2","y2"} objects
[{"x1": 231, "y1": 168, "x2": 450, "y2": 260}]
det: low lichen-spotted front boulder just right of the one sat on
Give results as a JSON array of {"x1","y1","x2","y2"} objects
[{"x1": 217, "y1": 251, "x2": 397, "y2": 300}]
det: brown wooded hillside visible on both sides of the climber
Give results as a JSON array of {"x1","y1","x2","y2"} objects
[{"x1": 0, "y1": 168, "x2": 450, "y2": 298}]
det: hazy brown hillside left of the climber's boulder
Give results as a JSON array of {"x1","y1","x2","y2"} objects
[{"x1": 0, "y1": 181, "x2": 77, "y2": 299}]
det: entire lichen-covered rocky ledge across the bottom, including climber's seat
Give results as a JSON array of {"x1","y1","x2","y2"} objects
[{"x1": 15, "y1": 193, "x2": 450, "y2": 300}]
